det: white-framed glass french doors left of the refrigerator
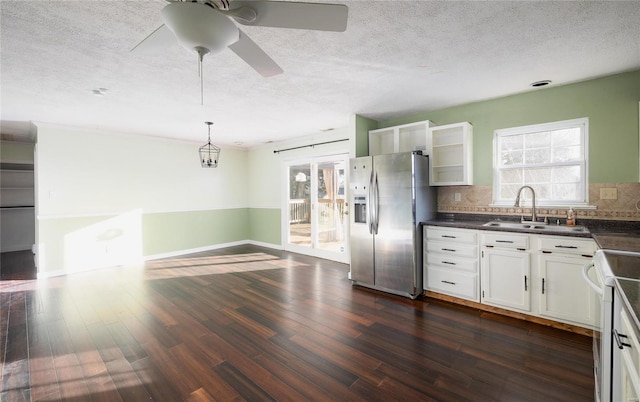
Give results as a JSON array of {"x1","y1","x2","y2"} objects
[{"x1": 282, "y1": 154, "x2": 349, "y2": 263}]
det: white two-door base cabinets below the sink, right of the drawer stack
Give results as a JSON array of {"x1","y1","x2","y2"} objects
[{"x1": 480, "y1": 232, "x2": 597, "y2": 328}]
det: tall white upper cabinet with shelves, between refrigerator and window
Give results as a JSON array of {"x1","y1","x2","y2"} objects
[{"x1": 429, "y1": 122, "x2": 473, "y2": 186}]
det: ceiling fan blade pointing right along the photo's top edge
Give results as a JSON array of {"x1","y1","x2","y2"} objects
[{"x1": 226, "y1": 0, "x2": 349, "y2": 32}]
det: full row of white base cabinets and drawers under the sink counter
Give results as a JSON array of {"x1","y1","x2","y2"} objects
[{"x1": 424, "y1": 226, "x2": 598, "y2": 328}]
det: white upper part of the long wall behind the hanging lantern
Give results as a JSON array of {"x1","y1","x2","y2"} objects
[{"x1": 36, "y1": 125, "x2": 248, "y2": 217}]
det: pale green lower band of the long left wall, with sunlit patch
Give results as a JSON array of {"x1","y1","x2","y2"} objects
[{"x1": 39, "y1": 208, "x2": 250, "y2": 275}]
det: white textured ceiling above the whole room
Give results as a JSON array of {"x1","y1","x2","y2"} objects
[{"x1": 0, "y1": 0, "x2": 640, "y2": 146}]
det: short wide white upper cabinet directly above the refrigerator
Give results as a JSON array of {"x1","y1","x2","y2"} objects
[{"x1": 369, "y1": 120, "x2": 431, "y2": 155}]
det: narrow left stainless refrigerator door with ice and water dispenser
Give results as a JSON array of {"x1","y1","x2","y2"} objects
[{"x1": 349, "y1": 156, "x2": 375, "y2": 286}]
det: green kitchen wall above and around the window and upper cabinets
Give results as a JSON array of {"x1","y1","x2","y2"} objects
[{"x1": 370, "y1": 70, "x2": 640, "y2": 185}]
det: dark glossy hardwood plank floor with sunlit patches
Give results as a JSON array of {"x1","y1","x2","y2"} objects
[{"x1": 0, "y1": 246, "x2": 593, "y2": 402}]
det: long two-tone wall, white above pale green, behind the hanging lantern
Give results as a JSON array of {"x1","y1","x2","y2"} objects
[{"x1": 36, "y1": 124, "x2": 250, "y2": 276}]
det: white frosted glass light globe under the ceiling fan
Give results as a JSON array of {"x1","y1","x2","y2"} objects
[{"x1": 162, "y1": 2, "x2": 240, "y2": 53}]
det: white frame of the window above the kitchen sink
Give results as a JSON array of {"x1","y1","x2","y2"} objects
[{"x1": 492, "y1": 117, "x2": 590, "y2": 208}]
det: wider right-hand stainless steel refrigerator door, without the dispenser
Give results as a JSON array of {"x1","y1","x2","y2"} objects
[{"x1": 373, "y1": 153, "x2": 419, "y2": 294}]
